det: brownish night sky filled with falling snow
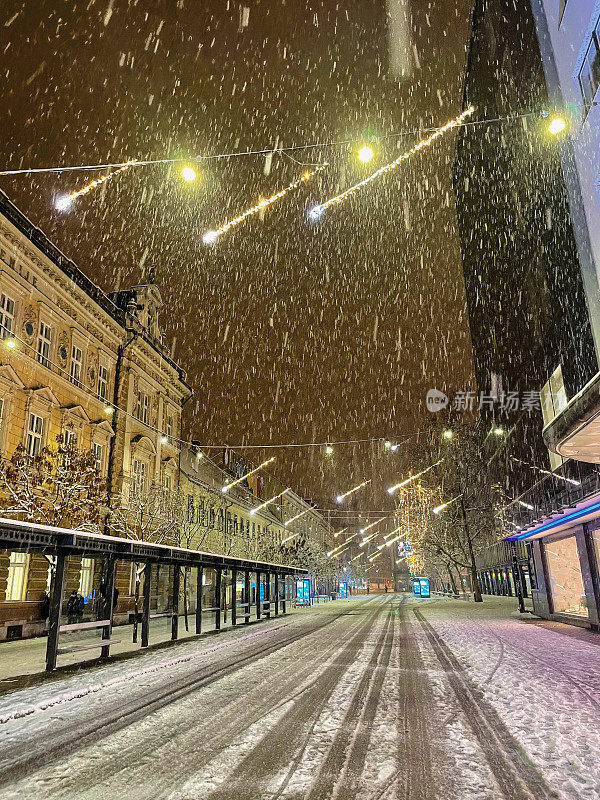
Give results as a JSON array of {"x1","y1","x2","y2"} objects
[{"x1": 0, "y1": 0, "x2": 473, "y2": 508}]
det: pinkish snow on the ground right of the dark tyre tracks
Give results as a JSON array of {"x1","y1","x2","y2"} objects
[{"x1": 415, "y1": 598, "x2": 600, "y2": 800}]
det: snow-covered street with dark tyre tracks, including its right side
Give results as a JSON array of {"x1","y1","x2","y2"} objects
[{"x1": 0, "y1": 595, "x2": 600, "y2": 800}]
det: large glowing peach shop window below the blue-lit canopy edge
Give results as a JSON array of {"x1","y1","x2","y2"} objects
[{"x1": 544, "y1": 536, "x2": 588, "y2": 617}]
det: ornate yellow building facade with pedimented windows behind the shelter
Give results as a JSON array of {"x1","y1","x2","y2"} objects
[{"x1": 0, "y1": 193, "x2": 192, "y2": 639}]
